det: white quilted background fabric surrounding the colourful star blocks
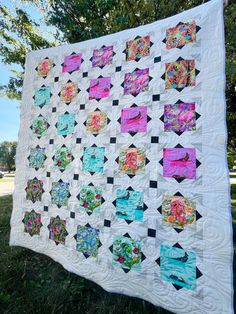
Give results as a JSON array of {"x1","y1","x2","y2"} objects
[{"x1": 10, "y1": 0, "x2": 233, "y2": 314}]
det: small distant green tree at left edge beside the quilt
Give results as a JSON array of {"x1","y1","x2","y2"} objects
[{"x1": 0, "y1": 142, "x2": 17, "y2": 172}]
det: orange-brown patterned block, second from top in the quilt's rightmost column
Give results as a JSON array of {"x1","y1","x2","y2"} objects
[{"x1": 165, "y1": 59, "x2": 196, "y2": 90}]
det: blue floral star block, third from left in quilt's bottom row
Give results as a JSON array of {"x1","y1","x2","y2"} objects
[{"x1": 76, "y1": 224, "x2": 101, "y2": 258}]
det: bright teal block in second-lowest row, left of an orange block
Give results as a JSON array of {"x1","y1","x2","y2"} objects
[{"x1": 116, "y1": 189, "x2": 143, "y2": 221}]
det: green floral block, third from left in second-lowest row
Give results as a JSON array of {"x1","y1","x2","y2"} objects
[{"x1": 78, "y1": 185, "x2": 103, "y2": 215}]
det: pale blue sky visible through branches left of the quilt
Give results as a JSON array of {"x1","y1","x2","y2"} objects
[{"x1": 0, "y1": 0, "x2": 55, "y2": 142}]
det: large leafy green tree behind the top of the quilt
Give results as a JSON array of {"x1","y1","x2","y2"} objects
[{"x1": 0, "y1": 0, "x2": 236, "y2": 150}]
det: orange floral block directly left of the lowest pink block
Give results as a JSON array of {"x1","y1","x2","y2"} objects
[{"x1": 119, "y1": 147, "x2": 146, "y2": 175}]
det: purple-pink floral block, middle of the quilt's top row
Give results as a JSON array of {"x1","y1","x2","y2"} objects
[{"x1": 92, "y1": 46, "x2": 114, "y2": 68}]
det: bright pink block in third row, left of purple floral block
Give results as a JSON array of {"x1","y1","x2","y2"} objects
[{"x1": 121, "y1": 106, "x2": 147, "y2": 133}]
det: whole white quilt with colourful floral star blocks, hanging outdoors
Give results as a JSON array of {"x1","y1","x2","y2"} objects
[{"x1": 10, "y1": 0, "x2": 233, "y2": 314}]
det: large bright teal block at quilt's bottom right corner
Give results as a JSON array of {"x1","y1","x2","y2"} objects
[{"x1": 160, "y1": 245, "x2": 196, "y2": 290}]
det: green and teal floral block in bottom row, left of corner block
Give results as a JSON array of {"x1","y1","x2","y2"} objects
[{"x1": 112, "y1": 236, "x2": 142, "y2": 271}]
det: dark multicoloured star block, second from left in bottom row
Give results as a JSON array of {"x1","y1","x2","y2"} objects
[{"x1": 48, "y1": 216, "x2": 68, "y2": 245}]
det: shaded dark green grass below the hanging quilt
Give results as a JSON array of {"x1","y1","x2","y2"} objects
[{"x1": 0, "y1": 196, "x2": 170, "y2": 314}]
